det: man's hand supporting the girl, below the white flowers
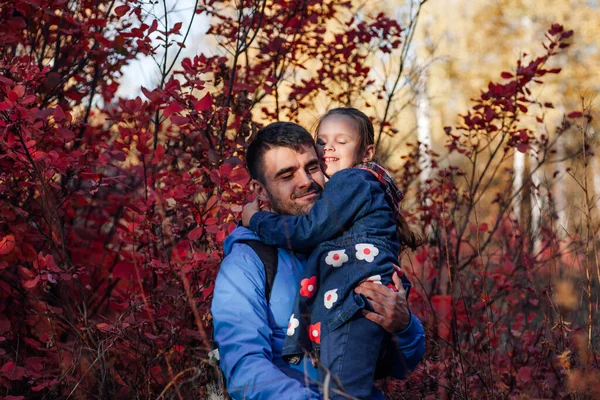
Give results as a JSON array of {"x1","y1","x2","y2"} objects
[{"x1": 354, "y1": 267, "x2": 410, "y2": 333}]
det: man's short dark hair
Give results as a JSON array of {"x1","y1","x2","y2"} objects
[{"x1": 246, "y1": 122, "x2": 315, "y2": 184}]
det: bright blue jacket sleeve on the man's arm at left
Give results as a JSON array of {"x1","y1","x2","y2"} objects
[{"x1": 211, "y1": 255, "x2": 319, "y2": 400}]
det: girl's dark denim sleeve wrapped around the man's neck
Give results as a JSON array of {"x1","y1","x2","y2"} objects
[{"x1": 250, "y1": 168, "x2": 373, "y2": 251}]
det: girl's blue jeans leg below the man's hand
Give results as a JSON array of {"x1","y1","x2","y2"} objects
[{"x1": 319, "y1": 311, "x2": 387, "y2": 400}]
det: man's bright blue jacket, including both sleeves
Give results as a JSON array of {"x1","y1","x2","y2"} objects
[{"x1": 211, "y1": 227, "x2": 425, "y2": 400}]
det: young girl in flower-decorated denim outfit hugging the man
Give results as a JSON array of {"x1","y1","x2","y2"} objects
[{"x1": 244, "y1": 108, "x2": 415, "y2": 399}]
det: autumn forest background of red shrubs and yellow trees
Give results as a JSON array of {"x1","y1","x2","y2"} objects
[{"x1": 0, "y1": 0, "x2": 600, "y2": 400}]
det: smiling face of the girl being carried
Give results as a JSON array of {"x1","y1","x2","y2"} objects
[{"x1": 317, "y1": 114, "x2": 370, "y2": 177}]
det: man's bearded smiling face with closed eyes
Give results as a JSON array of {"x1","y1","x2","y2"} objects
[{"x1": 263, "y1": 146, "x2": 325, "y2": 215}]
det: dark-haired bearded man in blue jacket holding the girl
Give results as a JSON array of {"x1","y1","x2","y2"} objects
[{"x1": 211, "y1": 122, "x2": 425, "y2": 399}]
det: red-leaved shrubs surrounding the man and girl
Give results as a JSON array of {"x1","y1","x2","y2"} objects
[{"x1": 0, "y1": 0, "x2": 591, "y2": 399}]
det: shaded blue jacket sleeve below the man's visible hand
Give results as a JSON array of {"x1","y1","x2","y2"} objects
[{"x1": 391, "y1": 313, "x2": 425, "y2": 379}]
